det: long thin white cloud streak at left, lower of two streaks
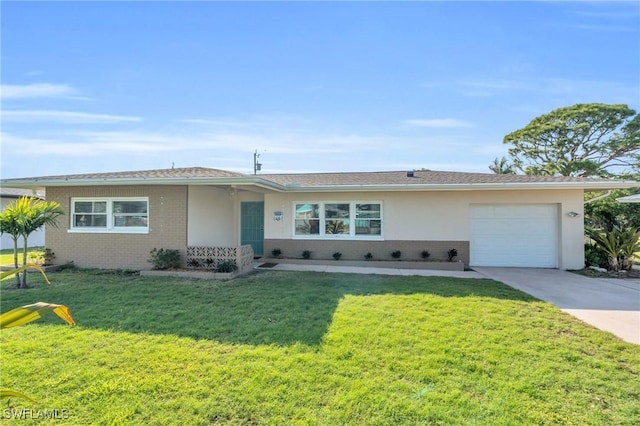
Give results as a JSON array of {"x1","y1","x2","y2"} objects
[{"x1": 2, "y1": 110, "x2": 142, "y2": 124}]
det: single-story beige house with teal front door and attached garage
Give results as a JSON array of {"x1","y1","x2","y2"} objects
[{"x1": 2, "y1": 167, "x2": 640, "y2": 269}]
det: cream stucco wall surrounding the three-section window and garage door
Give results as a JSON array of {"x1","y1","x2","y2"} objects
[{"x1": 265, "y1": 189, "x2": 584, "y2": 269}]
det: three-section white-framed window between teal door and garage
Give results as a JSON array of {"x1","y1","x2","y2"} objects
[{"x1": 293, "y1": 202, "x2": 382, "y2": 238}]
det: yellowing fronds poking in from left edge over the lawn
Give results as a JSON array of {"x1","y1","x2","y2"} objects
[{"x1": 0, "y1": 264, "x2": 76, "y2": 403}]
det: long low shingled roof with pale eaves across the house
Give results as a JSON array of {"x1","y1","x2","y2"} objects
[{"x1": 2, "y1": 167, "x2": 640, "y2": 192}]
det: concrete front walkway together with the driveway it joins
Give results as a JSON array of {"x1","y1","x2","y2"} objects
[{"x1": 254, "y1": 262, "x2": 640, "y2": 344}]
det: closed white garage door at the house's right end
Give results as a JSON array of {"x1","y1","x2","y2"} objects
[{"x1": 469, "y1": 204, "x2": 558, "y2": 268}]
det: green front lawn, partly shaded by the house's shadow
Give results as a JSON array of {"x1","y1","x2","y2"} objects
[{"x1": 0, "y1": 271, "x2": 640, "y2": 425}]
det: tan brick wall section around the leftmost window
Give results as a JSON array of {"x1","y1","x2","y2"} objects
[{"x1": 46, "y1": 186, "x2": 188, "y2": 269}]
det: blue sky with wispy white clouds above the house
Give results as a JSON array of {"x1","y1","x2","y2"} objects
[{"x1": 0, "y1": 1, "x2": 640, "y2": 178}]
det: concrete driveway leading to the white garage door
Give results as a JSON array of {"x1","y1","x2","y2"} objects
[{"x1": 473, "y1": 267, "x2": 640, "y2": 344}]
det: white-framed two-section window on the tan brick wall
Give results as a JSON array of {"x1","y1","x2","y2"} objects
[{"x1": 70, "y1": 198, "x2": 149, "y2": 233}]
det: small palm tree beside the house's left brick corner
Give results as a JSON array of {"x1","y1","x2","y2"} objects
[{"x1": 0, "y1": 197, "x2": 64, "y2": 288}]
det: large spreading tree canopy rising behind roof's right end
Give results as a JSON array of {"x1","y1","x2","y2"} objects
[{"x1": 500, "y1": 103, "x2": 640, "y2": 177}]
